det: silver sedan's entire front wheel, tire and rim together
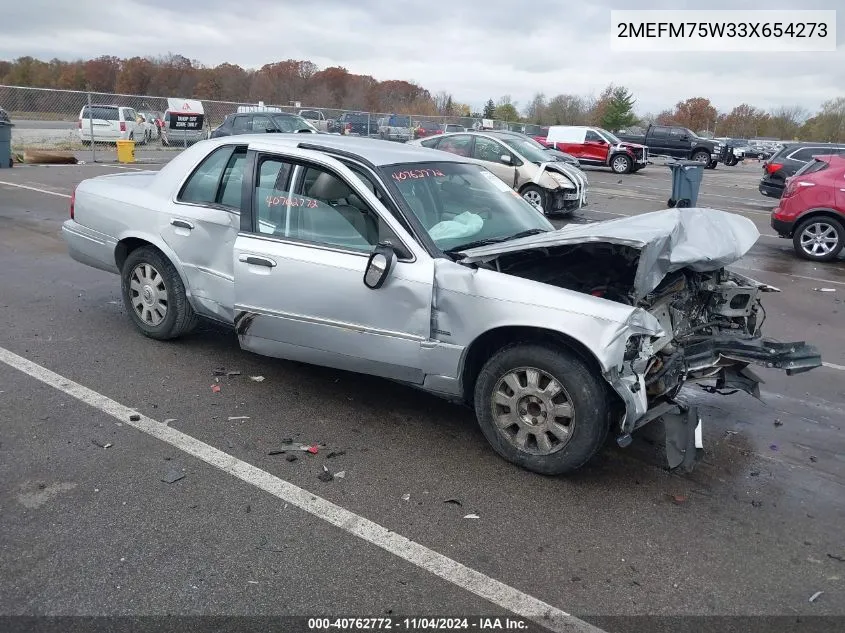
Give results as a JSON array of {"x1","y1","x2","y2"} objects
[{"x1": 474, "y1": 343, "x2": 610, "y2": 475}]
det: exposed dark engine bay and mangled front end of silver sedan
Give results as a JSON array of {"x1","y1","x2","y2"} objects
[{"x1": 474, "y1": 242, "x2": 820, "y2": 422}]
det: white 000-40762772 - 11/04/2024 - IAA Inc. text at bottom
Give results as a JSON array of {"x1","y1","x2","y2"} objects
[{"x1": 308, "y1": 617, "x2": 539, "y2": 632}]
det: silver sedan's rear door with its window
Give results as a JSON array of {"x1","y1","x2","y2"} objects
[{"x1": 159, "y1": 143, "x2": 247, "y2": 322}]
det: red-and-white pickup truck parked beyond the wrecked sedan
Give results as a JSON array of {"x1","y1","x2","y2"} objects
[{"x1": 535, "y1": 125, "x2": 648, "y2": 174}]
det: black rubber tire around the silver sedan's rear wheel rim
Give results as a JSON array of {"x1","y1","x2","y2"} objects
[{"x1": 120, "y1": 246, "x2": 198, "y2": 340}]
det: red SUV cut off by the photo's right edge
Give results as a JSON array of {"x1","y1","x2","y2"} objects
[{"x1": 772, "y1": 155, "x2": 845, "y2": 262}]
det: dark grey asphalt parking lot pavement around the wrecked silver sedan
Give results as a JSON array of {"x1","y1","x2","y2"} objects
[{"x1": 0, "y1": 154, "x2": 845, "y2": 632}]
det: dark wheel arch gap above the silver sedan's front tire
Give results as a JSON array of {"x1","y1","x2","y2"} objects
[{"x1": 460, "y1": 325, "x2": 621, "y2": 406}]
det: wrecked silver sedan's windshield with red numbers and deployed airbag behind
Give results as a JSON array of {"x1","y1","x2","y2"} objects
[{"x1": 382, "y1": 162, "x2": 554, "y2": 251}]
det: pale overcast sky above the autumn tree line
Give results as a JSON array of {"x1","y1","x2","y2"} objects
[{"x1": 0, "y1": 0, "x2": 845, "y2": 114}]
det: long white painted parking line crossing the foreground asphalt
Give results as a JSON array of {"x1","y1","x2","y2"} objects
[{"x1": 0, "y1": 347, "x2": 605, "y2": 633}]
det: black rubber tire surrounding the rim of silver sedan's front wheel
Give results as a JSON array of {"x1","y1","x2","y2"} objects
[{"x1": 474, "y1": 343, "x2": 610, "y2": 475}]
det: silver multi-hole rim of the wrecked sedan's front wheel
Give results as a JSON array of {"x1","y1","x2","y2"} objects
[{"x1": 491, "y1": 367, "x2": 575, "y2": 455}]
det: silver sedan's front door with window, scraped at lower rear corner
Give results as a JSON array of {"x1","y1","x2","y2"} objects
[{"x1": 234, "y1": 154, "x2": 434, "y2": 383}]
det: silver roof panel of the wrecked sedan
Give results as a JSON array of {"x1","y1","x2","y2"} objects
[{"x1": 212, "y1": 134, "x2": 470, "y2": 166}]
